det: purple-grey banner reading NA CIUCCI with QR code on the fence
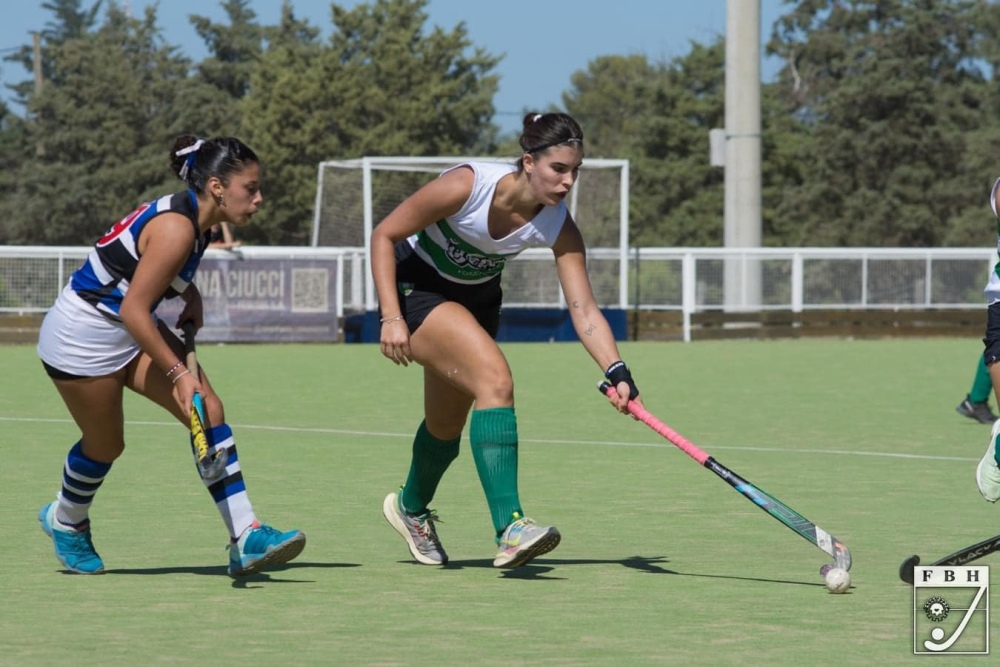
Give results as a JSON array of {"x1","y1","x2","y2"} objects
[{"x1": 156, "y1": 255, "x2": 340, "y2": 343}]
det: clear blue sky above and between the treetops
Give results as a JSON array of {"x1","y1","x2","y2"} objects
[{"x1": 0, "y1": 0, "x2": 787, "y2": 131}]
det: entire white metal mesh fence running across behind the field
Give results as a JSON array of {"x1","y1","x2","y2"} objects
[{"x1": 0, "y1": 246, "x2": 997, "y2": 340}]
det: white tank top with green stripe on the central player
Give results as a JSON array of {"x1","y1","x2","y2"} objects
[{"x1": 407, "y1": 162, "x2": 566, "y2": 285}]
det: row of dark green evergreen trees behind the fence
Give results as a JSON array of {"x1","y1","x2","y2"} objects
[{"x1": 0, "y1": 0, "x2": 1000, "y2": 247}]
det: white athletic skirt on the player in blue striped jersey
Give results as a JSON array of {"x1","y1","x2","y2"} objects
[{"x1": 38, "y1": 285, "x2": 148, "y2": 377}]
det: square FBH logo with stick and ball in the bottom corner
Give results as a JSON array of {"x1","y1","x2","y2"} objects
[{"x1": 913, "y1": 565, "x2": 990, "y2": 655}]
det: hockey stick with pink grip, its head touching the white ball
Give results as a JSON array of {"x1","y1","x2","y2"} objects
[{"x1": 597, "y1": 382, "x2": 851, "y2": 576}]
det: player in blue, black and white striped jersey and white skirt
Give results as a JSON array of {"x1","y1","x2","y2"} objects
[{"x1": 38, "y1": 135, "x2": 305, "y2": 576}]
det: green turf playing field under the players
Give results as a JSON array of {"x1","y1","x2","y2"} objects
[{"x1": 0, "y1": 339, "x2": 1000, "y2": 667}]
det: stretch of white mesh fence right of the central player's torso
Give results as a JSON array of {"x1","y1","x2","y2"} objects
[{"x1": 504, "y1": 248, "x2": 997, "y2": 313}]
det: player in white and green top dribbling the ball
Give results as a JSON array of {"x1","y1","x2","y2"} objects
[{"x1": 371, "y1": 113, "x2": 638, "y2": 568}]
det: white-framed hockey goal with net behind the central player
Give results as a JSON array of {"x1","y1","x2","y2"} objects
[{"x1": 312, "y1": 157, "x2": 629, "y2": 311}]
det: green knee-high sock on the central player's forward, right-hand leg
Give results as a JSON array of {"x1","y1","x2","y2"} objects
[{"x1": 469, "y1": 407, "x2": 523, "y2": 534}]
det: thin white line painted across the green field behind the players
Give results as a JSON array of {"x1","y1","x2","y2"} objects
[{"x1": 0, "y1": 417, "x2": 981, "y2": 463}]
